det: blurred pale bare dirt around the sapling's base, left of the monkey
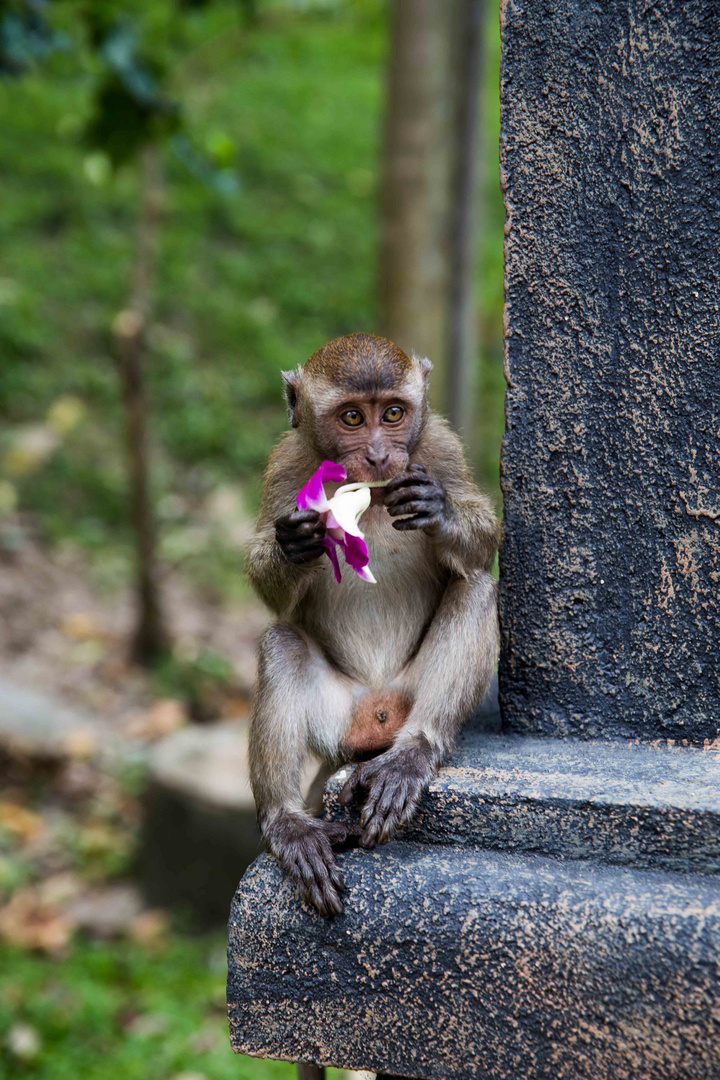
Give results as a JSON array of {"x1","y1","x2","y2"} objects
[{"x1": 0, "y1": 511, "x2": 268, "y2": 726}]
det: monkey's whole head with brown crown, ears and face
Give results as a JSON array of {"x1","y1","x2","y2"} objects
[{"x1": 283, "y1": 334, "x2": 433, "y2": 481}]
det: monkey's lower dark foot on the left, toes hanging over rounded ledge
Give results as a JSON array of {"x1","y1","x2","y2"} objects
[{"x1": 264, "y1": 812, "x2": 362, "y2": 917}]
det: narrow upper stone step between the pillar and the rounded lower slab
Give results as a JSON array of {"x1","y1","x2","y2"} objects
[{"x1": 325, "y1": 728, "x2": 720, "y2": 874}]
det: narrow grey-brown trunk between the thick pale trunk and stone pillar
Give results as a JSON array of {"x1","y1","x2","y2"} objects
[{"x1": 445, "y1": 0, "x2": 485, "y2": 441}]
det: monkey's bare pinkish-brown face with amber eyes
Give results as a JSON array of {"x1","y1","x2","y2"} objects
[{"x1": 316, "y1": 391, "x2": 420, "y2": 482}]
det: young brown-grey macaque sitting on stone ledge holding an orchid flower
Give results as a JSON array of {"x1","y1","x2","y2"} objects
[{"x1": 248, "y1": 334, "x2": 498, "y2": 916}]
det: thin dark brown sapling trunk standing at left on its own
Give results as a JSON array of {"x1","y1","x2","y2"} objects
[{"x1": 113, "y1": 145, "x2": 168, "y2": 665}]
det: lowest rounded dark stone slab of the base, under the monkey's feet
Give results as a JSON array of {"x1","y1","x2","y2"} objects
[{"x1": 229, "y1": 843, "x2": 720, "y2": 1080}]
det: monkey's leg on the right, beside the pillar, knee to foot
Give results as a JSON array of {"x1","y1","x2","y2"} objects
[{"x1": 340, "y1": 571, "x2": 498, "y2": 848}]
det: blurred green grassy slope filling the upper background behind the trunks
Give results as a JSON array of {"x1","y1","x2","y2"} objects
[{"x1": 0, "y1": 0, "x2": 504, "y2": 572}]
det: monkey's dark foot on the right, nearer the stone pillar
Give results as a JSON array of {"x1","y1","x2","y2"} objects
[{"x1": 340, "y1": 735, "x2": 436, "y2": 848}]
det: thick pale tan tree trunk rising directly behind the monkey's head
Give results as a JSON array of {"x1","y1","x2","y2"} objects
[{"x1": 380, "y1": 0, "x2": 453, "y2": 408}]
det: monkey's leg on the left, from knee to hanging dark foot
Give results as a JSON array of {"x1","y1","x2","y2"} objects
[{"x1": 249, "y1": 623, "x2": 359, "y2": 915}]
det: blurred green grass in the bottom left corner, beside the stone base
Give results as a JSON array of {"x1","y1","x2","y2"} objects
[{"x1": 0, "y1": 935, "x2": 349, "y2": 1080}]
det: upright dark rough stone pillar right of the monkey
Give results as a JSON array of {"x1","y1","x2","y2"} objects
[{"x1": 501, "y1": 0, "x2": 720, "y2": 744}]
